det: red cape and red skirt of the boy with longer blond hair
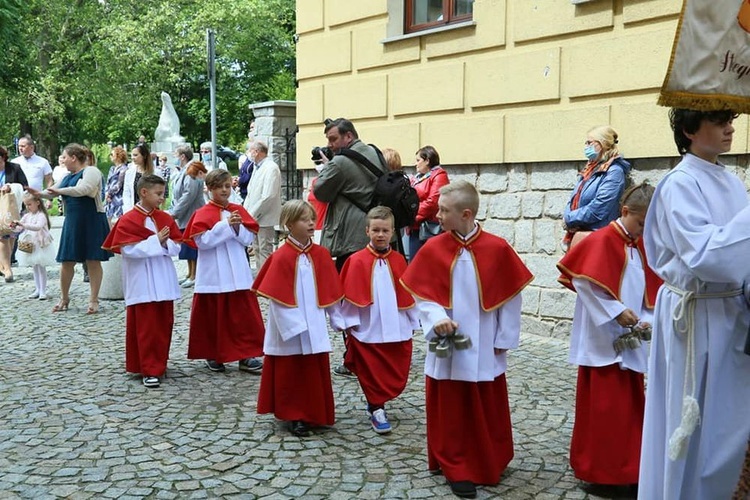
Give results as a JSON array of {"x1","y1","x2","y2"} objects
[{"x1": 253, "y1": 240, "x2": 343, "y2": 425}]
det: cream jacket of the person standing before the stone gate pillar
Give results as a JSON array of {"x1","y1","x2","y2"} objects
[{"x1": 244, "y1": 157, "x2": 281, "y2": 227}]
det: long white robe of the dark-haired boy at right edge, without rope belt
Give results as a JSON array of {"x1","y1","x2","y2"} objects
[{"x1": 639, "y1": 154, "x2": 750, "y2": 500}]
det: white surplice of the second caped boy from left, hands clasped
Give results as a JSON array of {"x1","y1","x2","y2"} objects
[{"x1": 195, "y1": 210, "x2": 255, "y2": 293}]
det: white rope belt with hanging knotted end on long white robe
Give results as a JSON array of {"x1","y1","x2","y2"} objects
[{"x1": 664, "y1": 283, "x2": 742, "y2": 460}]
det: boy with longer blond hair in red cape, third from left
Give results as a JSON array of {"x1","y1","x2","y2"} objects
[{"x1": 253, "y1": 200, "x2": 343, "y2": 436}]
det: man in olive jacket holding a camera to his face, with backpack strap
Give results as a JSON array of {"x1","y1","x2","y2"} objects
[{"x1": 313, "y1": 118, "x2": 387, "y2": 271}]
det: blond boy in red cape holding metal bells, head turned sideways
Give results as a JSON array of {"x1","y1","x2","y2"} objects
[{"x1": 401, "y1": 181, "x2": 533, "y2": 498}]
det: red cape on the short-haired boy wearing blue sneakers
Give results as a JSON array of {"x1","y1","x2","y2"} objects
[{"x1": 341, "y1": 245, "x2": 414, "y2": 309}]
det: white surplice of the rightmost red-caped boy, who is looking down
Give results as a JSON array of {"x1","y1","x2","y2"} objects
[{"x1": 568, "y1": 229, "x2": 653, "y2": 373}]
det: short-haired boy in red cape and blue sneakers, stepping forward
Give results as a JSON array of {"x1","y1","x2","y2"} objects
[{"x1": 341, "y1": 206, "x2": 419, "y2": 434}]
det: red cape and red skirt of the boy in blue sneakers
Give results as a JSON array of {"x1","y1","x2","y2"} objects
[{"x1": 341, "y1": 245, "x2": 414, "y2": 406}]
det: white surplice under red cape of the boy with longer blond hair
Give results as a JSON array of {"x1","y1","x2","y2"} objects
[{"x1": 263, "y1": 253, "x2": 343, "y2": 356}]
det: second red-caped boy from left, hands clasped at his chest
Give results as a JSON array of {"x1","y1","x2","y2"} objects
[{"x1": 185, "y1": 169, "x2": 264, "y2": 373}]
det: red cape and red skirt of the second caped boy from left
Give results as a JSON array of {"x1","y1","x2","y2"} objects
[{"x1": 183, "y1": 200, "x2": 264, "y2": 363}]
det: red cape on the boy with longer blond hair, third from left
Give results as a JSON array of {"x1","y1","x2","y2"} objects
[{"x1": 252, "y1": 240, "x2": 344, "y2": 308}]
